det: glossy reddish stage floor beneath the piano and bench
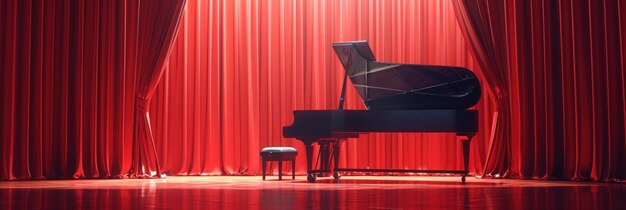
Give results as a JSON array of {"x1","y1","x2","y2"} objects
[{"x1": 0, "y1": 176, "x2": 626, "y2": 209}]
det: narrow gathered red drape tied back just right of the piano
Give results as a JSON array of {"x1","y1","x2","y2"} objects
[{"x1": 452, "y1": 0, "x2": 514, "y2": 177}]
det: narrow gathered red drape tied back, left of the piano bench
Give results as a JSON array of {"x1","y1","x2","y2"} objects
[{"x1": 129, "y1": 0, "x2": 185, "y2": 178}]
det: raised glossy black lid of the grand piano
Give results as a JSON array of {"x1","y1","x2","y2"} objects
[{"x1": 333, "y1": 41, "x2": 481, "y2": 110}]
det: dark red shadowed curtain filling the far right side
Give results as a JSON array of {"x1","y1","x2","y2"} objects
[{"x1": 453, "y1": 0, "x2": 626, "y2": 181}]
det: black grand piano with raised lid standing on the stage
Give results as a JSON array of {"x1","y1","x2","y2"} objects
[{"x1": 283, "y1": 41, "x2": 481, "y2": 182}]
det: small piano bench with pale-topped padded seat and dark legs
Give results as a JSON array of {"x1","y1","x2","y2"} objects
[{"x1": 261, "y1": 147, "x2": 298, "y2": 180}]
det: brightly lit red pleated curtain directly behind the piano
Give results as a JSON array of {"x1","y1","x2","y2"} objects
[{"x1": 151, "y1": 0, "x2": 493, "y2": 175}]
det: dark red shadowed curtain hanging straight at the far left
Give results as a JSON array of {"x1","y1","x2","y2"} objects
[{"x1": 0, "y1": 0, "x2": 182, "y2": 180}]
